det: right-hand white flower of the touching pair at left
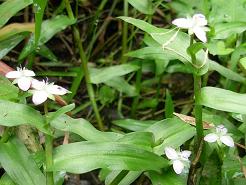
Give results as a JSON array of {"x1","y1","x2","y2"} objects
[{"x1": 29, "y1": 79, "x2": 69, "y2": 105}]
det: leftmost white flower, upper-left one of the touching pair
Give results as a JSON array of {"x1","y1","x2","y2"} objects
[{"x1": 5, "y1": 67, "x2": 35, "y2": 91}]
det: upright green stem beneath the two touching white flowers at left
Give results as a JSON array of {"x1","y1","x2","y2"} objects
[{"x1": 44, "y1": 102, "x2": 54, "y2": 185}]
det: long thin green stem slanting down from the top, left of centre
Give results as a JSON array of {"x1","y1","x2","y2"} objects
[{"x1": 66, "y1": 0, "x2": 104, "y2": 130}]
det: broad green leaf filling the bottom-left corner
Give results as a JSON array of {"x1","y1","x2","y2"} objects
[{"x1": 0, "y1": 139, "x2": 46, "y2": 185}]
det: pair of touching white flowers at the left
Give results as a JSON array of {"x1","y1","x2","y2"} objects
[{"x1": 6, "y1": 68, "x2": 69, "y2": 105}]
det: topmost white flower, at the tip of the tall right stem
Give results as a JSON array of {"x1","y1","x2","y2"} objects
[{"x1": 172, "y1": 14, "x2": 209, "y2": 42}]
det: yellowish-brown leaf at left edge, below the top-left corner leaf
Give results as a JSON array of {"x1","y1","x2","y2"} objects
[{"x1": 0, "y1": 23, "x2": 34, "y2": 41}]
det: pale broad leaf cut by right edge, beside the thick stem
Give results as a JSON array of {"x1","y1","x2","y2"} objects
[{"x1": 199, "y1": 87, "x2": 246, "y2": 114}]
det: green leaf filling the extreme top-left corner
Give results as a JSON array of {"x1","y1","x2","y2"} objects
[{"x1": 0, "y1": 0, "x2": 32, "y2": 27}]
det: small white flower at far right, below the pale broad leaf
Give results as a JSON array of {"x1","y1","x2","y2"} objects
[{"x1": 204, "y1": 125, "x2": 234, "y2": 147}]
